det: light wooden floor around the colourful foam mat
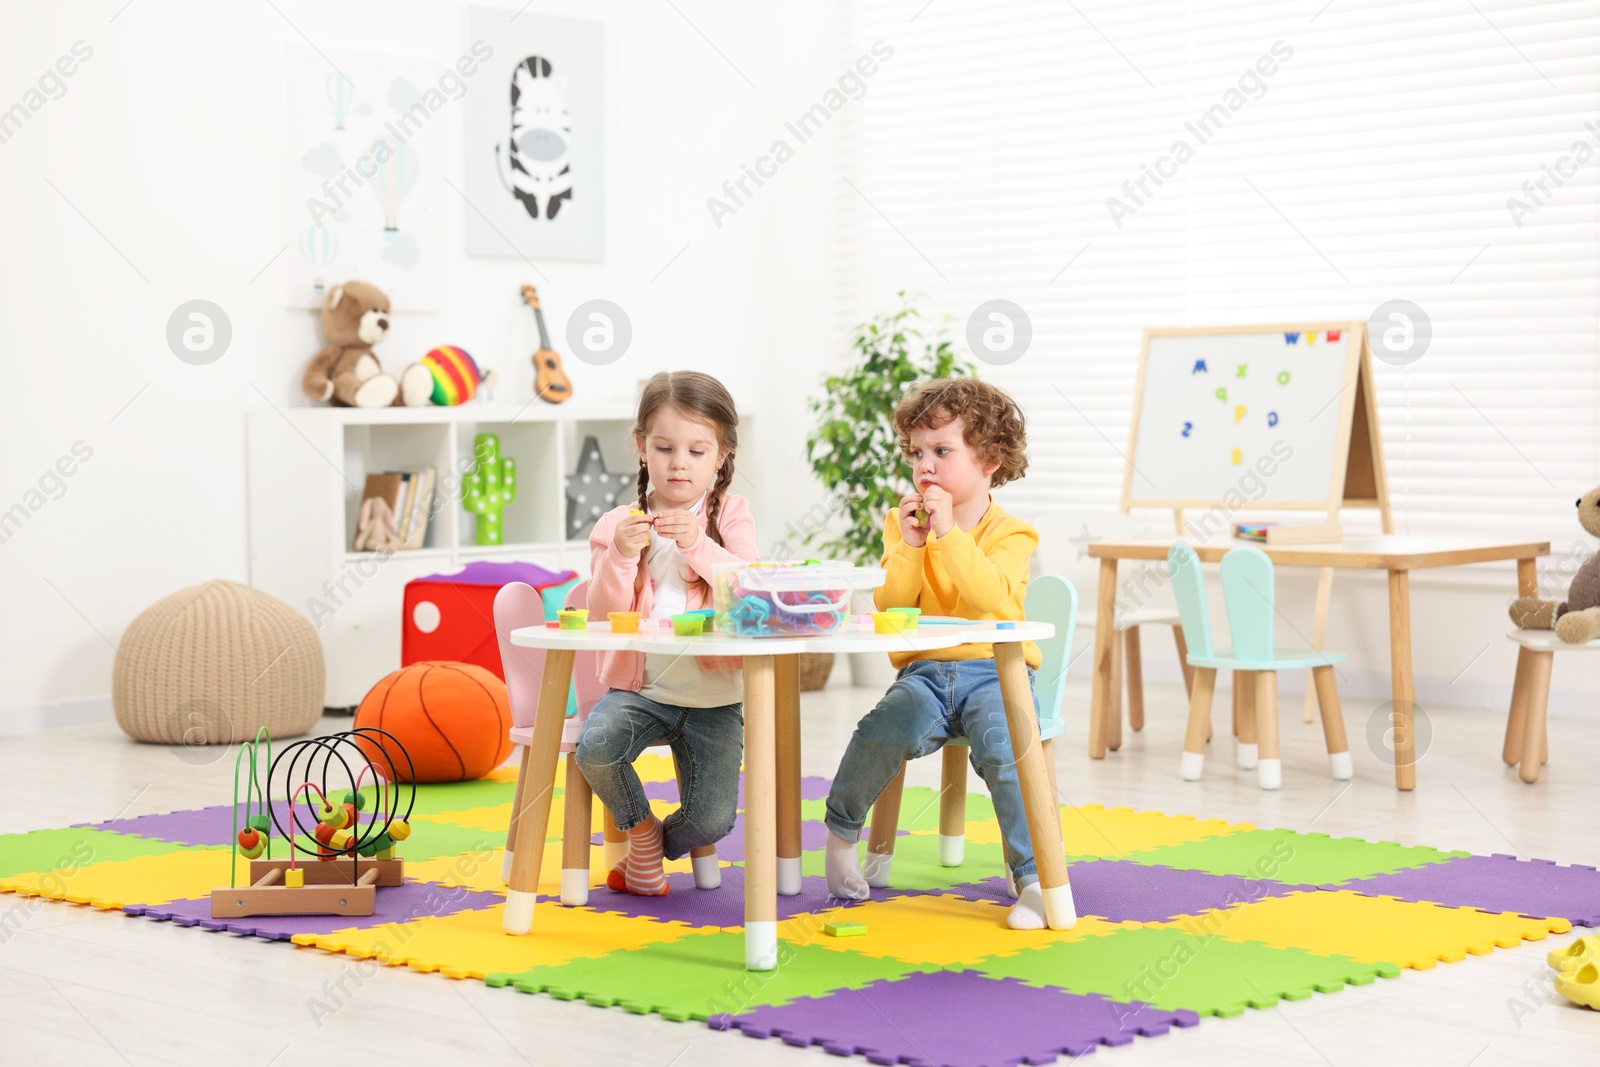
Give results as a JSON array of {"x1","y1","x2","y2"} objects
[{"x1": 0, "y1": 681, "x2": 1600, "y2": 1067}]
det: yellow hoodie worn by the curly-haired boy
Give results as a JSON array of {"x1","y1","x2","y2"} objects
[{"x1": 874, "y1": 498, "x2": 1040, "y2": 670}]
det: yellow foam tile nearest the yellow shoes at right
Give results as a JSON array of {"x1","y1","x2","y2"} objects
[{"x1": 1149, "y1": 889, "x2": 1571, "y2": 971}]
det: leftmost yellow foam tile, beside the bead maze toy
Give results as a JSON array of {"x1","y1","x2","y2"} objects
[{"x1": 0, "y1": 848, "x2": 250, "y2": 909}]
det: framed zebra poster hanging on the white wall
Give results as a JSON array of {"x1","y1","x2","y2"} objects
[{"x1": 466, "y1": 8, "x2": 605, "y2": 261}]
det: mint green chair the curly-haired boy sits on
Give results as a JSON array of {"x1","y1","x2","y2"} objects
[{"x1": 862, "y1": 574, "x2": 1078, "y2": 896}]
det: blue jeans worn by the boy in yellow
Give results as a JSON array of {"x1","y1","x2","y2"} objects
[{"x1": 826, "y1": 659, "x2": 1038, "y2": 888}]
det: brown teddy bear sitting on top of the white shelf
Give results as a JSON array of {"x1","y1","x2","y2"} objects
[{"x1": 301, "y1": 282, "x2": 434, "y2": 408}]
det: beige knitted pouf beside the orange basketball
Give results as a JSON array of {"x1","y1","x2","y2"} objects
[{"x1": 110, "y1": 581, "x2": 323, "y2": 745}]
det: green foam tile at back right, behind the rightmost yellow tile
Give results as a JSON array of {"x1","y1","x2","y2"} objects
[{"x1": 1126, "y1": 830, "x2": 1467, "y2": 886}]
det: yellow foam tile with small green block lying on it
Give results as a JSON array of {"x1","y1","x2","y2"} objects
[{"x1": 796, "y1": 894, "x2": 1139, "y2": 966}]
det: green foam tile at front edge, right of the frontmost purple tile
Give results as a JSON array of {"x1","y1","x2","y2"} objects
[{"x1": 962, "y1": 928, "x2": 1400, "y2": 1016}]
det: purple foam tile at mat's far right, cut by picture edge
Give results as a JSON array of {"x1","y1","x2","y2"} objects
[{"x1": 1322, "y1": 856, "x2": 1600, "y2": 926}]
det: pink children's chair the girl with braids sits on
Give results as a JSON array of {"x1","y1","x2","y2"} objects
[{"x1": 494, "y1": 581, "x2": 722, "y2": 905}]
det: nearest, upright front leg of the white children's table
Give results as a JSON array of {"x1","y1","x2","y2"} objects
[{"x1": 744, "y1": 656, "x2": 778, "y2": 971}]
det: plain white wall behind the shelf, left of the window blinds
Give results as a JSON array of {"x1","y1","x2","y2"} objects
[{"x1": 0, "y1": 0, "x2": 830, "y2": 718}]
